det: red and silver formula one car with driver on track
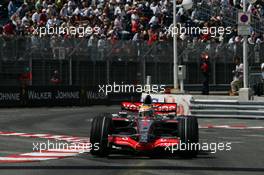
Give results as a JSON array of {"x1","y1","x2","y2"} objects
[{"x1": 90, "y1": 96, "x2": 199, "y2": 157}]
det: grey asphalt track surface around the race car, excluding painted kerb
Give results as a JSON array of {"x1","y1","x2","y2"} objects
[{"x1": 0, "y1": 106, "x2": 264, "y2": 175}]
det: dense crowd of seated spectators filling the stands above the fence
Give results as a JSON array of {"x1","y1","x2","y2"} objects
[{"x1": 0, "y1": 0, "x2": 264, "y2": 52}]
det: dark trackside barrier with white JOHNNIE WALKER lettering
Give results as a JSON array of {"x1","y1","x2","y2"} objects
[{"x1": 0, "y1": 86, "x2": 141, "y2": 107}]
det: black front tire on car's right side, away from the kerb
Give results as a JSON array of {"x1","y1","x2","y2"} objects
[{"x1": 178, "y1": 116, "x2": 199, "y2": 158}]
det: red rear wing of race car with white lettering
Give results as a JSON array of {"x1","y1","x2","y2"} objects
[{"x1": 121, "y1": 102, "x2": 177, "y2": 113}]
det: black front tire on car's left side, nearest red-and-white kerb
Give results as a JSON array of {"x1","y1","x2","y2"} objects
[{"x1": 90, "y1": 114, "x2": 112, "y2": 157}]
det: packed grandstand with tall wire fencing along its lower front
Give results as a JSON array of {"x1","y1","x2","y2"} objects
[{"x1": 0, "y1": 0, "x2": 264, "y2": 90}]
